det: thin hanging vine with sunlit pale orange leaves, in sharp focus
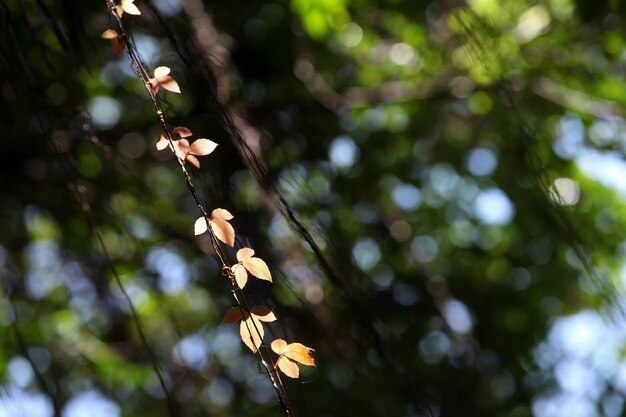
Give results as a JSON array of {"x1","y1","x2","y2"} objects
[{"x1": 102, "y1": 0, "x2": 315, "y2": 416}]
